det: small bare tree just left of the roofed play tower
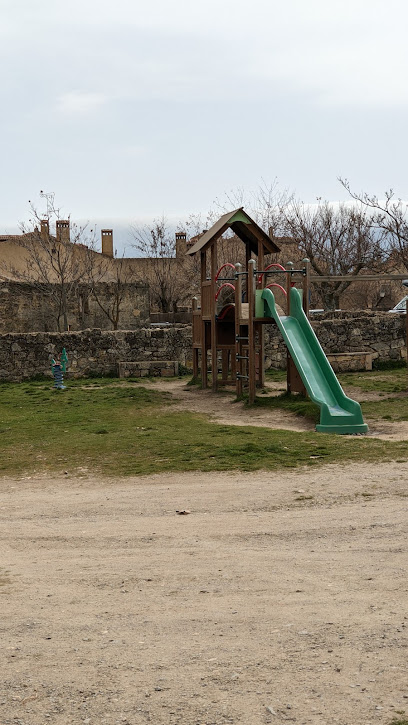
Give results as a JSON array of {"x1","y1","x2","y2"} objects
[{"x1": 131, "y1": 217, "x2": 191, "y2": 312}]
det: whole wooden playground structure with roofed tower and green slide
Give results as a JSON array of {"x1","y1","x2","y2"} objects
[{"x1": 187, "y1": 207, "x2": 368, "y2": 433}]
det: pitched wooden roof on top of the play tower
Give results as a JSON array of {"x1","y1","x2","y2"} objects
[{"x1": 187, "y1": 206, "x2": 280, "y2": 255}]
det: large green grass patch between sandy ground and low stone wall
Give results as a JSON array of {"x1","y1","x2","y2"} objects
[{"x1": 0, "y1": 379, "x2": 406, "y2": 476}]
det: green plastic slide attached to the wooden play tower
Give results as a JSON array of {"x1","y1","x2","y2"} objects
[{"x1": 256, "y1": 287, "x2": 368, "y2": 434}]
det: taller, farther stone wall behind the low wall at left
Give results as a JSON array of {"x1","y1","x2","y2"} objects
[{"x1": 0, "y1": 282, "x2": 150, "y2": 334}]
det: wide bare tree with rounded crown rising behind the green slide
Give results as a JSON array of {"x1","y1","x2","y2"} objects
[{"x1": 281, "y1": 200, "x2": 384, "y2": 309}]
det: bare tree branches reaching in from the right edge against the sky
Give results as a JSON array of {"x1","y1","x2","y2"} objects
[{"x1": 339, "y1": 179, "x2": 408, "y2": 270}]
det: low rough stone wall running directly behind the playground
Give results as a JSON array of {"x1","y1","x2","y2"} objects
[{"x1": 0, "y1": 313, "x2": 406, "y2": 381}]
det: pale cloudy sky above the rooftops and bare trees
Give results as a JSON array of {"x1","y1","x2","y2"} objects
[{"x1": 0, "y1": 0, "x2": 408, "y2": 251}]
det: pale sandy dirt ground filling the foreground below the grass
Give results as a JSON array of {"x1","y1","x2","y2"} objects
[{"x1": 0, "y1": 462, "x2": 408, "y2": 725}]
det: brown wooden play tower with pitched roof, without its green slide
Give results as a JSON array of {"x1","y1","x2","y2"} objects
[{"x1": 187, "y1": 207, "x2": 309, "y2": 403}]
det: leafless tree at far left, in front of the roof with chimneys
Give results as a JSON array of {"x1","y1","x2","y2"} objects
[{"x1": 2, "y1": 192, "x2": 93, "y2": 331}]
